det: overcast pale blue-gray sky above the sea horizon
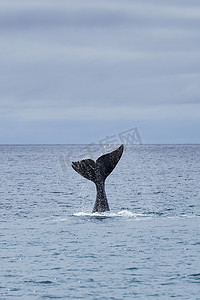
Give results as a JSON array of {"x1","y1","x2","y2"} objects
[{"x1": 0, "y1": 0, "x2": 200, "y2": 144}]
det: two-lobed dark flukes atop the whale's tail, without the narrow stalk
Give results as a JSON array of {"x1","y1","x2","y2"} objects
[{"x1": 72, "y1": 145, "x2": 124, "y2": 183}]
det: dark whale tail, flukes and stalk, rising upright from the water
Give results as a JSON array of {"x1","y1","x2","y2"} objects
[{"x1": 71, "y1": 144, "x2": 124, "y2": 213}]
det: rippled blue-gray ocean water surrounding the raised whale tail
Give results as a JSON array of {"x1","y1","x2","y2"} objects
[{"x1": 0, "y1": 145, "x2": 200, "y2": 300}]
